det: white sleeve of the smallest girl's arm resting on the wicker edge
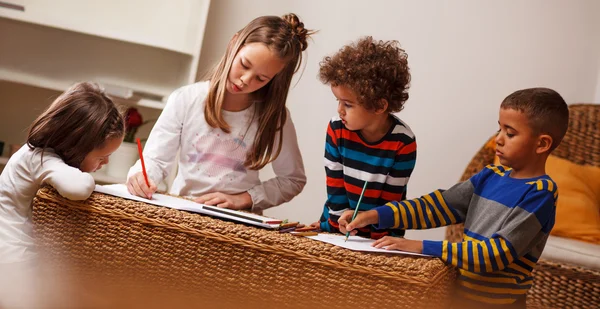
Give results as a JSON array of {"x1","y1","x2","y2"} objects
[{"x1": 37, "y1": 151, "x2": 96, "y2": 201}]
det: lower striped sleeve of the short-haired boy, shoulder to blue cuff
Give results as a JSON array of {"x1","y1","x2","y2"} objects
[{"x1": 423, "y1": 179, "x2": 558, "y2": 272}]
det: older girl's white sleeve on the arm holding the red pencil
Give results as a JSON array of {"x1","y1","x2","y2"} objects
[{"x1": 127, "y1": 90, "x2": 187, "y2": 185}]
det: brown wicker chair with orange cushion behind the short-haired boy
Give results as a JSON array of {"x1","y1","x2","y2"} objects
[{"x1": 446, "y1": 104, "x2": 600, "y2": 308}]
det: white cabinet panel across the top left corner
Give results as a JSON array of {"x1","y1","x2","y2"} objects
[{"x1": 0, "y1": 0, "x2": 210, "y2": 55}]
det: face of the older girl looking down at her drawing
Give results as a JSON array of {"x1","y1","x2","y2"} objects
[{"x1": 226, "y1": 43, "x2": 286, "y2": 94}]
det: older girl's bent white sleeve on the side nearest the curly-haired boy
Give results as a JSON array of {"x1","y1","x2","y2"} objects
[{"x1": 248, "y1": 111, "x2": 306, "y2": 211}]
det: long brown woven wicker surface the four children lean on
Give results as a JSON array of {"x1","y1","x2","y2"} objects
[{"x1": 33, "y1": 187, "x2": 456, "y2": 308}]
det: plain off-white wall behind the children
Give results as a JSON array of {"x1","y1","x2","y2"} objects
[{"x1": 200, "y1": 0, "x2": 600, "y2": 239}]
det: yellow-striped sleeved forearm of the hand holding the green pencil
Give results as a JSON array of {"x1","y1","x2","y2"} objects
[{"x1": 375, "y1": 190, "x2": 459, "y2": 230}]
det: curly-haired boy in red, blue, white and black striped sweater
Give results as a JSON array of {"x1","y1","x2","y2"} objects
[{"x1": 313, "y1": 37, "x2": 417, "y2": 239}]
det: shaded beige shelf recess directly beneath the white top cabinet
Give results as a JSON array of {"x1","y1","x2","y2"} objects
[{"x1": 0, "y1": 17, "x2": 193, "y2": 109}]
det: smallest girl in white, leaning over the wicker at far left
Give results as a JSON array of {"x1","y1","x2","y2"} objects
[{"x1": 0, "y1": 83, "x2": 125, "y2": 308}]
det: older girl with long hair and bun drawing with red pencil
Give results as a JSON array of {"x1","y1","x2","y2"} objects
[{"x1": 127, "y1": 14, "x2": 313, "y2": 212}]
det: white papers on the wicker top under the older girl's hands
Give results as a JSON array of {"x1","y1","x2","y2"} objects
[{"x1": 94, "y1": 184, "x2": 279, "y2": 229}]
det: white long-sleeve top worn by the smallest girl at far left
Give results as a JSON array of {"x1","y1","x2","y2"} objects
[{"x1": 0, "y1": 145, "x2": 95, "y2": 264}]
